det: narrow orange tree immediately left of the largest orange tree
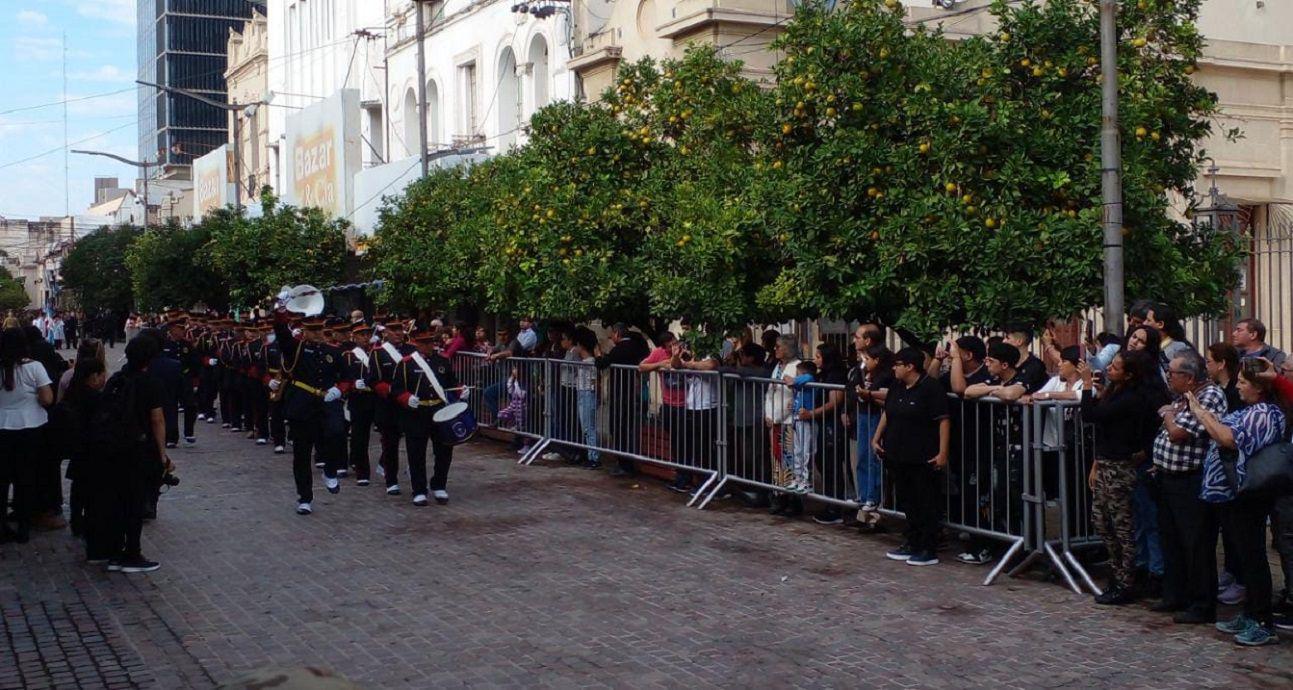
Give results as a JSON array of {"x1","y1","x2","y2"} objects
[{"x1": 604, "y1": 47, "x2": 773, "y2": 346}]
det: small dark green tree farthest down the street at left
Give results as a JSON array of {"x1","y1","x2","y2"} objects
[{"x1": 62, "y1": 225, "x2": 141, "y2": 314}]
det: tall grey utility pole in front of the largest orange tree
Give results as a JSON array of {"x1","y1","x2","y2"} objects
[{"x1": 1100, "y1": 0, "x2": 1125, "y2": 336}]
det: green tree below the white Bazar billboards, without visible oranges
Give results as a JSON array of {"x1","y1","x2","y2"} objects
[{"x1": 202, "y1": 189, "x2": 347, "y2": 308}]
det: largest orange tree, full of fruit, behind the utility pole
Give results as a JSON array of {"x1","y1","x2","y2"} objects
[{"x1": 759, "y1": 0, "x2": 1236, "y2": 335}]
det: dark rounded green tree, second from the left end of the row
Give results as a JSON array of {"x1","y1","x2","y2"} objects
[{"x1": 125, "y1": 221, "x2": 229, "y2": 311}]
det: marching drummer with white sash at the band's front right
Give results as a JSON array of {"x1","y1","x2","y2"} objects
[{"x1": 387, "y1": 329, "x2": 458, "y2": 505}]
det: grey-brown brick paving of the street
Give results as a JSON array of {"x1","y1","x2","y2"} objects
[{"x1": 0, "y1": 425, "x2": 1293, "y2": 689}]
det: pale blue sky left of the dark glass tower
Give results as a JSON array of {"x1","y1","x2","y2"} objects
[{"x1": 0, "y1": 0, "x2": 138, "y2": 218}]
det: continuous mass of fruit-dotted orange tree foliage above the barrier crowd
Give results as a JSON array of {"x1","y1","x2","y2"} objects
[{"x1": 374, "y1": 0, "x2": 1239, "y2": 336}]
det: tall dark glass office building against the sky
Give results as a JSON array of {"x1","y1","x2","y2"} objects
[{"x1": 137, "y1": 0, "x2": 257, "y2": 176}]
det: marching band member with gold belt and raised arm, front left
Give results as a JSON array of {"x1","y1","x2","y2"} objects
[{"x1": 274, "y1": 313, "x2": 341, "y2": 514}]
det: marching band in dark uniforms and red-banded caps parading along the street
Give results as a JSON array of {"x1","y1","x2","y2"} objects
[{"x1": 163, "y1": 288, "x2": 475, "y2": 516}]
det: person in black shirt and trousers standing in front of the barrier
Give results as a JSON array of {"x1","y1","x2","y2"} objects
[{"x1": 871, "y1": 348, "x2": 952, "y2": 566}]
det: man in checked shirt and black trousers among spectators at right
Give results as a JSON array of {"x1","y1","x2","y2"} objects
[{"x1": 1152, "y1": 350, "x2": 1226, "y2": 624}]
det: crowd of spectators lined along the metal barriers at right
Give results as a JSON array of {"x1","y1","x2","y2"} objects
[{"x1": 446, "y1": 301, "x2": 1293, "y2": 646}]
